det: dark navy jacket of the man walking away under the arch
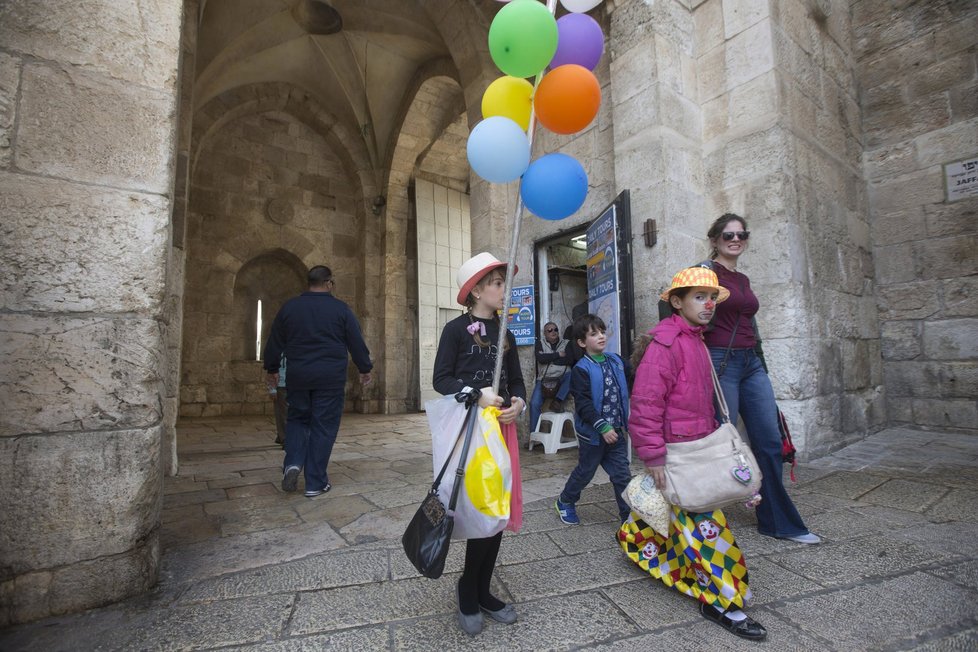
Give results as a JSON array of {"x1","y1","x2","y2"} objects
[{"x1": 265, "y1": 292, "x2": 373, "y2": 391}]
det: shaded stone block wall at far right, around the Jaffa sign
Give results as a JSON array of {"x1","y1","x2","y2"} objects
[{"x1": 852, "y1": 0, "x2": 978, "y2": 432}]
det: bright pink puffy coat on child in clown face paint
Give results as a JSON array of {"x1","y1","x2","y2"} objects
[{"x1": 628, "y1": 314, "x2": 719, "y2": 466}]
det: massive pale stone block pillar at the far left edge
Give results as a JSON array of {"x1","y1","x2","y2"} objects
[{"x1": 0, "y1": 0, "x2": 183, "y2": 626}]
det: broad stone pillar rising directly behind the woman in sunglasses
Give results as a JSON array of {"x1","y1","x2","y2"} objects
[{"x1": 696, "y1": 0, "x2": 883, "y2": 455}]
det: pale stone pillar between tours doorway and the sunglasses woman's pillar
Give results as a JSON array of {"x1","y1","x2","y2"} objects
[{"x1": 608, "y1": 0, "x2": 709, "y2": 332}]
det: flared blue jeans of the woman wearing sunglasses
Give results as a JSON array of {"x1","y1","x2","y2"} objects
[{"x1": 710, "y1": 347, "x2": 808, "y2": 537}]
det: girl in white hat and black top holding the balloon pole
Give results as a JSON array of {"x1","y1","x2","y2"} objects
[{"x1": 432, "y1": 252, "x2": 526, "y2": 636}]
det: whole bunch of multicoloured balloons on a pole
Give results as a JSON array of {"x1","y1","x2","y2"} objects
[{"x1": 466, "y1": 0, "x2": 604, "y2": 220}]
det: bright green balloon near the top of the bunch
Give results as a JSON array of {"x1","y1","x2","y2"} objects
[{"x1": 489, "y1": 0, "x2": 557, "y2": 77}]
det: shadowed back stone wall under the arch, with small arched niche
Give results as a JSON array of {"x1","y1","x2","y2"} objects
[{"x1": 180, "y1": 111, "x2": 362, "y2": 416}]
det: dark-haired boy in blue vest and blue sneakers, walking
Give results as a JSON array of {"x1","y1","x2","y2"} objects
[{"x1": 555, "y1": 315, "x2": 632, "y2": 525}]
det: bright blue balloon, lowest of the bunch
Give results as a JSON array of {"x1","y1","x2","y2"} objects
[{"x1": 520, "y1": 152, "x2": 587, "y2": 220}]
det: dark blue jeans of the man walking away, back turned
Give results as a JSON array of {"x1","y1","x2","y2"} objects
[{"x1": 283, "y1": 388, "x2": 343, "y2": 491}]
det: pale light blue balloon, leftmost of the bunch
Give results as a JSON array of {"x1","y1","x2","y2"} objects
[{"x1": 465, "y1": 115, "x2": 530, "y2": 183}]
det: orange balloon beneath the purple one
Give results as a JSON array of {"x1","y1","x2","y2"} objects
[{"x1": 533, "y1": 63, "x2": 601, "y2": 134}]
